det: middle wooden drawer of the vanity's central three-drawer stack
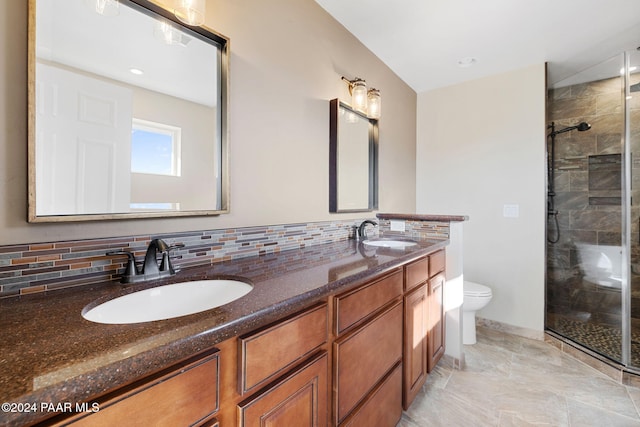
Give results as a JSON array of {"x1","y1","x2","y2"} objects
[{"x1": 334, "y1": 302, "x2": 403, "y2": 424}]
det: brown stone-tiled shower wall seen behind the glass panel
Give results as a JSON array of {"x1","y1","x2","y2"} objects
[{"x1": 547, "y1": 78, "x2": 624, "y2": 327}]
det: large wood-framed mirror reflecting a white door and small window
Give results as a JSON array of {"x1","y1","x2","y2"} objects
[{"x1": 28, "y1": 0, "x2": 229, "y2": 222}]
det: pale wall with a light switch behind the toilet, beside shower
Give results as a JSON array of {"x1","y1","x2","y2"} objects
[{"x1": 416, "y1": 64, "x2": 546, "y2": 331}]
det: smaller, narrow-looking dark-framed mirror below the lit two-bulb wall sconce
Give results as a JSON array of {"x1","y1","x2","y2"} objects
[{"x1": 329, "y1": 99, "x2": 378, "y2": 212}]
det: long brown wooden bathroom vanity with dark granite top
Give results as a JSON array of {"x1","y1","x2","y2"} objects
[{"x1": 0, "y1": 240, "x2": 448, "y2": 426}]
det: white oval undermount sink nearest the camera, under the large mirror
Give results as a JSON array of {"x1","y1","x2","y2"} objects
[{"x1": 82, "y1": 279, "x2": 253, "y2": 324}]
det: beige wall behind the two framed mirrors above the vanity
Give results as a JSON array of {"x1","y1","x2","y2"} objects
[{"x1": 0, "y1": 0, "x2": 416, "y2": 244}]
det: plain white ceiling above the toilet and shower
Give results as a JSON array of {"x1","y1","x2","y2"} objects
[{"x1": 316, "y1": 0, "x2": 640, "y2": 92}]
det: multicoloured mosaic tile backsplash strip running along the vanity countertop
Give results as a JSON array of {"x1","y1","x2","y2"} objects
[{"x1": 0, "y1": 219, "x2": 449, "y2": 297}]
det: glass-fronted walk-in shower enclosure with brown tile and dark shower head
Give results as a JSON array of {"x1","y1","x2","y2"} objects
[{"x1": 545, "y1": 51, "x2": 640, "y2": 371}]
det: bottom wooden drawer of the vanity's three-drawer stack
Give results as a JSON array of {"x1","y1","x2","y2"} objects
[{"x1": 341, "y1": 364, "x2": 402, "y2": 427}]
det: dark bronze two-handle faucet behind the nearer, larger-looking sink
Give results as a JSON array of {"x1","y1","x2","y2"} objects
[{"x1": 107, "y1": 239, "x2": 184, "y2": 283}]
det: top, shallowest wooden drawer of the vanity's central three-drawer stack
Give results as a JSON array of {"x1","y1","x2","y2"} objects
[{"x1": 335, "y1": 270, "x2": 402, "y2": 335}]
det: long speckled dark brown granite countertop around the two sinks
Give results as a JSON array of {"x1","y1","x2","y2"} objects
[{"x1": 0, "y1": 236, "x2": 448, "y2": 426}]
